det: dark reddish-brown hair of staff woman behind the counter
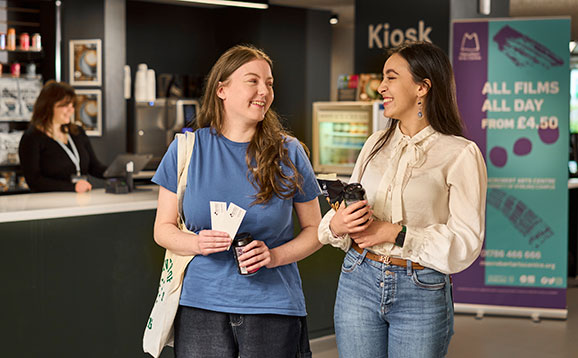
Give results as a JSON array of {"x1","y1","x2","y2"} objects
[{"x1": 30, "y1": 80, "x2": 78, "y2": 134}]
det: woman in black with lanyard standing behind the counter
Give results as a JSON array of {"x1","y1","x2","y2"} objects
[{"x1": 18, "y1": 81, "x2": 106, "y2": 193}]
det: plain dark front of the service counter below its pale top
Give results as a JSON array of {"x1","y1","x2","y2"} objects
[{"x1": 0, "y1": 197, "x2": 343, "y2": 358}]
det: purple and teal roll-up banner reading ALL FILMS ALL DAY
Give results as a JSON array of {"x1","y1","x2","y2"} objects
[{"x1": 451, "y1": 18, "x2": 570, "y2": 319}]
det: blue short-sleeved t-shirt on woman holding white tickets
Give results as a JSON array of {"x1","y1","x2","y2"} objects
[{"x1": 152, "y1": 128, "x2": 321, "y2": 316}]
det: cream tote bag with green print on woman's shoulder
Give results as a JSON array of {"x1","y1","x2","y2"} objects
[{"x1": 143, "y1": 132, "x2": 195, "y2": 358}]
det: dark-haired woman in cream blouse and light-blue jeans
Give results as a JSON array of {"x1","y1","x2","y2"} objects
[{"x1": 319, "y1": 42, "x2": 487, "y2": 358}]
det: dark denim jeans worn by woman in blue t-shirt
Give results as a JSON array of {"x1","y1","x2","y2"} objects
[{"x1": 174, "y1": 306, "x2": 311, "y2": 358}]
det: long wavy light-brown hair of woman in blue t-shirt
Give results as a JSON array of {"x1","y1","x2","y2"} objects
[{"x1": 196, "y1": 45, "x2": 307, "y2": 205}]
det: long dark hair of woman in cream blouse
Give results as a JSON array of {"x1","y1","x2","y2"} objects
[{"x1": 361, "y1": 41, "x2": 463, "y2": 175}]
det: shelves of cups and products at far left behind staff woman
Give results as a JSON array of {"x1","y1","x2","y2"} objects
[{"x1": 0, "y1": 0, "x2": 57, "y2": 195}]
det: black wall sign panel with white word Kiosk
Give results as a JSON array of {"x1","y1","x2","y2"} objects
[{"x1": 355, "y1": 0, "x2": 450, "y2": 73}]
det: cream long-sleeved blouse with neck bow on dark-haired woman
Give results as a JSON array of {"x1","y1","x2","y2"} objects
[{"x1": 319, "y1": 126, "x2": 487, "y2": 274}]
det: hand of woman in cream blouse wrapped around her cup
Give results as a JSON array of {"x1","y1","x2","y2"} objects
[{"x1": 329, "y1": 200, "x2": 373, "y2": 236}]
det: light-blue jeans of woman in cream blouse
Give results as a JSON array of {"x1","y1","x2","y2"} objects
[{"x1": 334, "y1": 249, "x2": 454, "y2": 358}]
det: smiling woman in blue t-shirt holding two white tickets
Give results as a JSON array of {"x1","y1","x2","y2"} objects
[{"x1": 153, "y1": 46, "x2": 321, "y2": 357}]
